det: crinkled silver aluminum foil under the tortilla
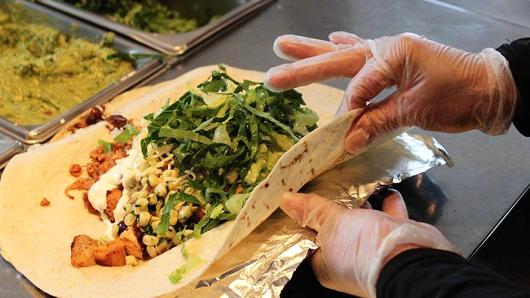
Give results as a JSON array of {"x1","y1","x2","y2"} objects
[{"x1": 172, "y1": 133, "x2": 452, "y2": 298}]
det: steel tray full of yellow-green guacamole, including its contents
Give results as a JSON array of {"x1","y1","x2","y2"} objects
[{"x1": 0, "y1": 0, "x2": 164, "y2": 143}]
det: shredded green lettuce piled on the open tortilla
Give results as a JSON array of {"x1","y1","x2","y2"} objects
[{"x1": 141, "y1": 67, "x2": 318, "y2": 237}]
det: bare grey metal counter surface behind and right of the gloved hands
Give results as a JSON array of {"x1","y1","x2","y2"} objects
[{"x1": 151, "y1": 0, "x2": 530, "y2": 256}]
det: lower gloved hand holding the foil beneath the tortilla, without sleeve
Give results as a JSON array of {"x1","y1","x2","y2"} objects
[{"x1": 280, "y1": 191, "x2": 453, "y2": 297}]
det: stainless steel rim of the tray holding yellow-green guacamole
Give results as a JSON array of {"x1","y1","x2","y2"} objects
[{"x1": 0, "y1": 0, "x2": 165, "y2": 144}]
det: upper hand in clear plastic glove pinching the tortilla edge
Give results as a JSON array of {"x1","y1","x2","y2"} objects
[{"x1": 265, "y1": 32, "x2": 517, "y2": 152}]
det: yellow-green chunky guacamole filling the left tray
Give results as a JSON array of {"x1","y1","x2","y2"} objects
[{"x1": 0, "y1": 7, "x2": 134, "y2": 125}]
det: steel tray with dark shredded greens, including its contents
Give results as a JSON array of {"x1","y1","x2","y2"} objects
[{"x1": 35, "y1": 0, "x2": 274, "y2": 54}]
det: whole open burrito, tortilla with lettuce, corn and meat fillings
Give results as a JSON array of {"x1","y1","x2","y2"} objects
[{"x1": 0, "y1": 66, "x2": 358, "y2": 297}]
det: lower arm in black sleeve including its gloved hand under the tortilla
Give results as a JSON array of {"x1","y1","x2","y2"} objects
[{"x1": 280, "y1": 191, "x2": 530, "y2": 298}]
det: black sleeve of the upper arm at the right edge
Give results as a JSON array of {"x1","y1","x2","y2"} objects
[{"x1": 497, "y1": 38, "x2": 530, "y2": 137}]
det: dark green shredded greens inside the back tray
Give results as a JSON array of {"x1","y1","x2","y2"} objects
[{"x1": 64, "y1": 0, "x2": 200, "y2": 34}]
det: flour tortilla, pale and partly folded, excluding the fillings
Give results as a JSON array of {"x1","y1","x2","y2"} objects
[{"x1": 0, "y1": 66, "x2": 359, "y2": 297}]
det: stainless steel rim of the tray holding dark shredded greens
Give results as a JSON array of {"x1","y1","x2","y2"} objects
[{"x1": 37, "y1": 0, "x2": 274, "y2": 56}]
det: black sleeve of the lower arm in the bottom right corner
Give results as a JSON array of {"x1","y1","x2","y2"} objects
[{"x1": 376, "y1": 248, "x2": 530, "y2": 298}]
